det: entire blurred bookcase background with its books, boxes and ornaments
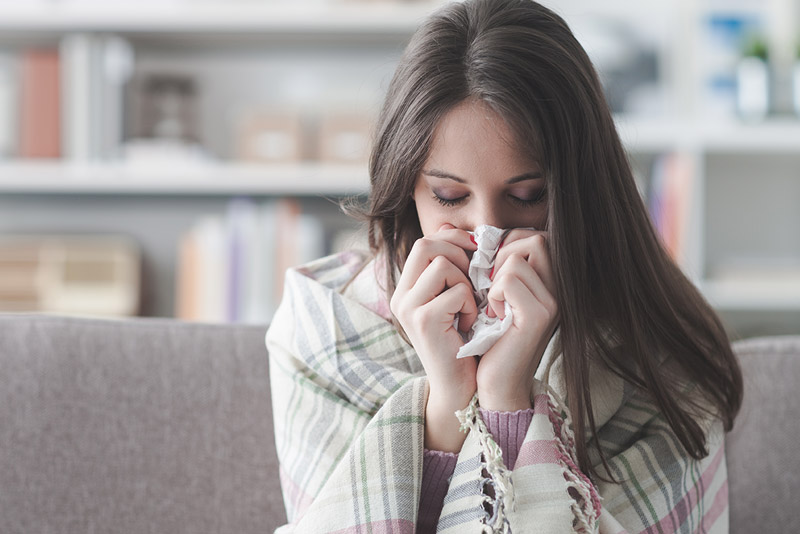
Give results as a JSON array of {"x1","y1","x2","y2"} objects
[{"x1": 0, "y1": 0, "x2": 800, "y2": 339}]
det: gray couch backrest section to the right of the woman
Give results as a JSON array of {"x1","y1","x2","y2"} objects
[{"x1": 725, "y1": 336, "x2": 800, "y2": 534}]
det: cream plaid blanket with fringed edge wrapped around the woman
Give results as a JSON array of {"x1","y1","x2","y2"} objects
[{"x1": 266, "y1": 253, "x2": 728, "y2": 534}]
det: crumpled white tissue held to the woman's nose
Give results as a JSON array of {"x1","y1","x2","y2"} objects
[{"x1": 456, "y1": 225, "x2": 512, "y2": 358}]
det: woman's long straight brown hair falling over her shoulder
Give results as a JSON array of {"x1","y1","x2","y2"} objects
[{"x1": 366, "y1": 0, "x2": 742, "y2": 482}]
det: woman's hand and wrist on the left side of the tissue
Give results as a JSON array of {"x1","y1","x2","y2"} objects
[{"x1": 390, "y1": 225, "x2": 478, "y2": 452}]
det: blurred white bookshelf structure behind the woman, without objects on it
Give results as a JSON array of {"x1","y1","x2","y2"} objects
[{"x1": 0, "y1": 0, "x2": 800, "y2": 337}]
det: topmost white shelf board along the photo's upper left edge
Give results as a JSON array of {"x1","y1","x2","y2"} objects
[{"x1": 0, "y1": 0, "x2": 440, "y2": 34}]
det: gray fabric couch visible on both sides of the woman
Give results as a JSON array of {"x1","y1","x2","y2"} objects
[{"x1": 0, "y1": 316, "x2": 800, "y2": 534}]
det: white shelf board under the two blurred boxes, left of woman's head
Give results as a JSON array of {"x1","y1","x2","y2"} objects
[{"x1": 0, "y1": 162, "x2": 369, "y2": 196}]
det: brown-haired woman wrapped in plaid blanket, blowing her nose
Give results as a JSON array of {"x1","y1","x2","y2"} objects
[{"x1": 267, "y1": 0, "x2": 742, "y2": 533}]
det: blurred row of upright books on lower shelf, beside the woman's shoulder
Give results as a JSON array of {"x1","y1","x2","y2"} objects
[{"x1": 176, "y1": 198, "x2": 360, "y2": 323}]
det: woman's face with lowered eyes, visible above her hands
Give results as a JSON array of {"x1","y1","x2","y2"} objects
[{"x1": 414, "y1": 100, "x2": 547, "y2": 236}]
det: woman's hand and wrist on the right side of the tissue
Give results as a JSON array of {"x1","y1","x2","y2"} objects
[{"x1": 477, "y1": 230, "x2": 559, "y2": 411}]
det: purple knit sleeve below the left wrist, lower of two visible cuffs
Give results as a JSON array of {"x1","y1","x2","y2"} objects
[{"x1": 417, "y1": 449, "x2": 458, "y2": 533}]
